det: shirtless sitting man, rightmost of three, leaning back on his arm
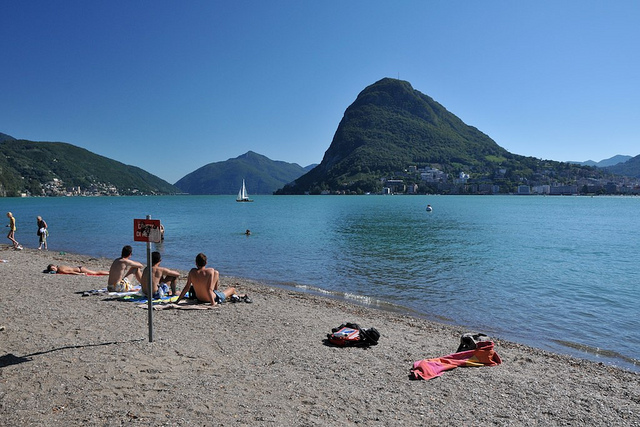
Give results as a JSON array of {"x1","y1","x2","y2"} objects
[{"x1": 176, "y1": 253, "x2": 251, "y2": 305}]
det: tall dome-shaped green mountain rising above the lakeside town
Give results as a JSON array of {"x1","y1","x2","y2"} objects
[{"x1": 278, "y1": 78, "x2": 597, "y2": 194}]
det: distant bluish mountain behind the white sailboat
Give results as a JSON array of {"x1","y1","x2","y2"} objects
[{"x1": 175, "y1": 151, "x2": 308, "y2": 194}]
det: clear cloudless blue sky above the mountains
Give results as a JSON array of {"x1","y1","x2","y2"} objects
[{"x1": 0, "y1": 0, "x2": 640, "y2": 183}]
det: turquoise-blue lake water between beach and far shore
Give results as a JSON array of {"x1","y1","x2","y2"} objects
[{"x1": 1, "y1": 196, "x2": 640, "y2": 371}]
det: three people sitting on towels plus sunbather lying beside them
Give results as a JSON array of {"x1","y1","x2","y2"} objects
[{"x1": 45, "y1": 245, "x2": 252, "y2": 306}]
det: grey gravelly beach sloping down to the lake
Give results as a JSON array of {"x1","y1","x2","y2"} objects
[{"x1": 0, "y1": 245, "x2": 640, "y2": 426}]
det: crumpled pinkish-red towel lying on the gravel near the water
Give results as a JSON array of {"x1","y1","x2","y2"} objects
[{"x1": 411, "y1": 341, "x2": 502, "y2": 380}]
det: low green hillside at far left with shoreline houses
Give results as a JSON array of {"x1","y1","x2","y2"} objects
[{"x1": 0, "y1": 137, "x2": 179, "y2": 196}]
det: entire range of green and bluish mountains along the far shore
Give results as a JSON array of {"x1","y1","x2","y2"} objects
[{"x1": 0, "y1": 78, "x2": 640, "y2": 196}]
